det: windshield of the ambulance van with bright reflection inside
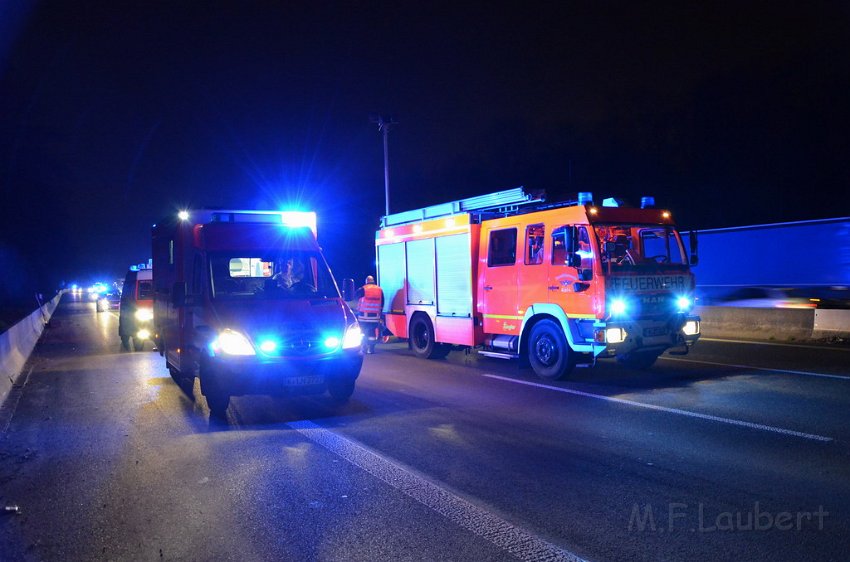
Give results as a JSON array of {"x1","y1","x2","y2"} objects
[{"x1": 210, "y1": 250, "x2": 339, "y2": 300}]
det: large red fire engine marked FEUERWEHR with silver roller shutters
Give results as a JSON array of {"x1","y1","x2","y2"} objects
[{"x1": 375, "y1": 188, "x2": 700, "y2": 379}]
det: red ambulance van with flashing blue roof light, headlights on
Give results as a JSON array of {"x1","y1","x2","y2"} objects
[{"x1": 153, "y1": 211, "x2": 363, "y2": 416}]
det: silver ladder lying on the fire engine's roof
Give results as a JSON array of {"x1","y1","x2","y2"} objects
[{"x1": 381, "y1": 187, "x2": 546, "y2": 228}]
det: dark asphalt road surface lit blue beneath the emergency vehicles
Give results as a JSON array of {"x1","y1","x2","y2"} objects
[{"x1": 0, "y1": 296, "x2": 850, "y2": 561}]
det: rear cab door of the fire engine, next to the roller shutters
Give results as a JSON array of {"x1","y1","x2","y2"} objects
[{"x1": 481, "y1": 227, "x2": 522, "y2": 335}]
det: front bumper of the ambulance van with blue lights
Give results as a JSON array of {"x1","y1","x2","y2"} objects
[{"x1": 209, "y1": 349, "x2": 363, "y2": 396}]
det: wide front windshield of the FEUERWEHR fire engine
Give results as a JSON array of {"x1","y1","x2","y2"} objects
[{"x1": 594, "y1": 224, "x2": 688, "y2": 272}]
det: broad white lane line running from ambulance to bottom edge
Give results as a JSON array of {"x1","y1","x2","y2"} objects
[{"x1": 287, "y1": 420, "x2": 582, "y2": 562}]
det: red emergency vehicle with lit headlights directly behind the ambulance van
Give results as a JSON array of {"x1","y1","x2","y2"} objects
[{"x1": 118, "y1": 266, "x2": 153, "y2": 351}]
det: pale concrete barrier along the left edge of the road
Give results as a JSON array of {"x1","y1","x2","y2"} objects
[{"x1": 0, "y1": 294, "x2": 62, "y2": 403}]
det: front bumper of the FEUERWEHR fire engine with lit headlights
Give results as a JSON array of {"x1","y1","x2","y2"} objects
[{"x1": 596, "y1": 315, "x2": 700, "y2": 357}]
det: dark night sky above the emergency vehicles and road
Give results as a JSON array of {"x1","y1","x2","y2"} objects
[{"x1": 0, "y1": 0, "x2": 850, "y2": 299}]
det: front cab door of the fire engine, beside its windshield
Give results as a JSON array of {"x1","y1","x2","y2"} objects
[{"x1": 548, "y1": 226, "x2": 596, "y2": 318}]
